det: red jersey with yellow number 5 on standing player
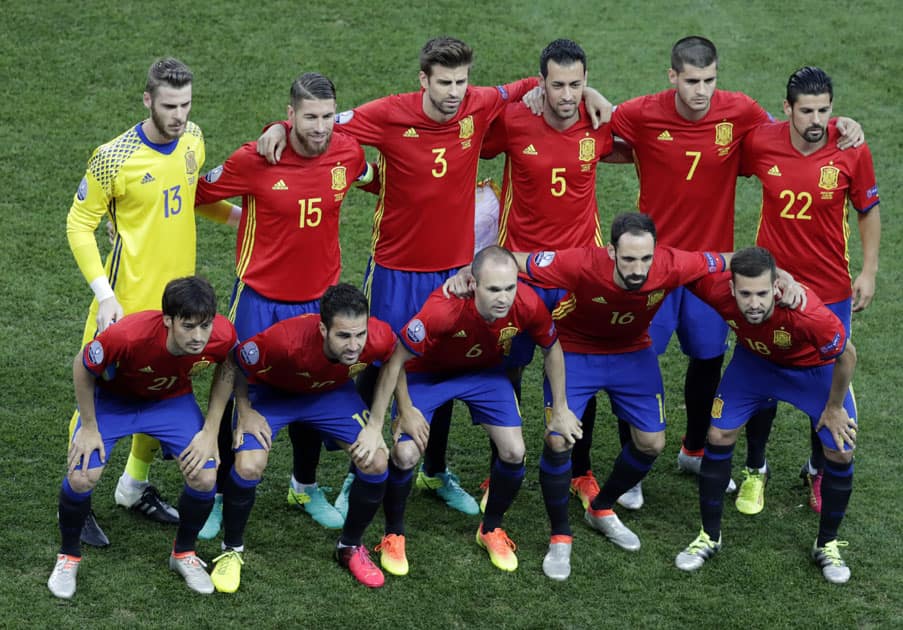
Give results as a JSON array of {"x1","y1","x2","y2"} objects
[{"x1": 481, "y1": 103, "x2": 613, "y2": 266}]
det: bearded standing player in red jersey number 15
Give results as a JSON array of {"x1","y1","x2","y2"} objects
[{"x1": 197, "y1": 72, "x2": 373, "y2": 539}]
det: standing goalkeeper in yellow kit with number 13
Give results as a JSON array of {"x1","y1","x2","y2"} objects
[{"x1": 66, "y1": 58, "x2": 237, "y2": 546}]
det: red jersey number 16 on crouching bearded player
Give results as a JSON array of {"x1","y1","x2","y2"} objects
[{"x1": 527, "y1": 246, "x2": 725, "y2": 354}]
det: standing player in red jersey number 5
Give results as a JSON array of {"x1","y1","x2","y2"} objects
[{"x1": 481, "y1": 39, "x2": 642, "y2": 509}]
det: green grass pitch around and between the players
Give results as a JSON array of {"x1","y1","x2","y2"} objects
[{"x1": 0, "y1": 0, "x2": 903, "y2": 628}]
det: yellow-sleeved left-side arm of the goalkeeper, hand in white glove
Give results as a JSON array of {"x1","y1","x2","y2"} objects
[{"x1": 66, "y1": 168, "x2": 124, "y2": 332}]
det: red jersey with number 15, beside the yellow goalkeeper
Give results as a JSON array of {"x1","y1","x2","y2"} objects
[{"x1": 195, "y1": 131, "x2": 369, "y2": 302}]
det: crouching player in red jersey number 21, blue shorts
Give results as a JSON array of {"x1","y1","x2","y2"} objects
[{"x1": 47, "y1": 276, "x2": 236, "y2": 599}]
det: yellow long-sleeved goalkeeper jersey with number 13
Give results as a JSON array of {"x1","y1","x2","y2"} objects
[{"x1": 66, "y1": 122, "x2": 205, "y2": 316}]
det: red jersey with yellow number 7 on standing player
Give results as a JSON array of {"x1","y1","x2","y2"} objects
[{"x1": 611, "y1": 89, "x2": 770, "y2": 252}]
